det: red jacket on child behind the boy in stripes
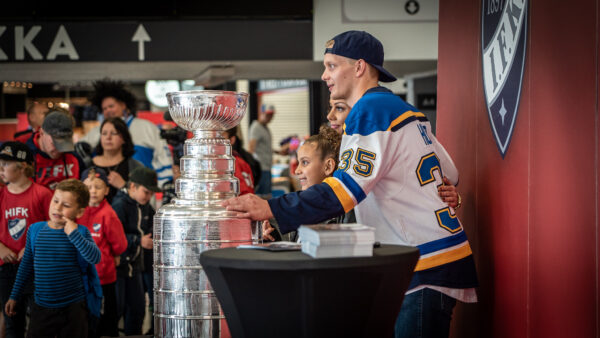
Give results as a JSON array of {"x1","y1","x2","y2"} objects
[{"x1": 77, "y1": 199, "x2": 127, "y2": 285}]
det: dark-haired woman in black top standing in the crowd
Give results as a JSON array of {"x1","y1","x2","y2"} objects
[{"x1": 92, "y1": 117, "x2": 143, "y2": 204}]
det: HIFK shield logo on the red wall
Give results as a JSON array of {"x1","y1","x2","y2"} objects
[{"x1": 481, "y1": 0, "x2": 527, "y2": 158}]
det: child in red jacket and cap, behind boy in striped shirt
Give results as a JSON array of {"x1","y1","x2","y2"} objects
[{"x1": 77, "y1": 167, "x2": 127, "y2": 337}]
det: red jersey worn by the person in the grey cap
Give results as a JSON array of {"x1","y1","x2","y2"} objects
[{"x1": 27, "y1": 133, "x2": 85, "y2": 190}]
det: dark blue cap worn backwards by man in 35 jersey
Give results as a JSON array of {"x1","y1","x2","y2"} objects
[{"x1": 325, "y1": 31, "x2": 397, "y2": 82}]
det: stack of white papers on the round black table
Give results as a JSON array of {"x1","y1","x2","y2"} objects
[{"x1": 298, "y1": 223, "x2": 375, "y2": 258}]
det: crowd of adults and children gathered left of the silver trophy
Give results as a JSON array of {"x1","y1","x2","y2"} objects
[{"x1": 0, "y1": 80, "x2": 173, "y2": 337}]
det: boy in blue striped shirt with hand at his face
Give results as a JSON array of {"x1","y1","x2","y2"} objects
[{"x1": 4, "y1": 179, "x2": 100, "y2": 337}]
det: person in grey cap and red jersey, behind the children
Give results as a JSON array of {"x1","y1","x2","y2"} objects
[{"x1": 27, "y1": 110, "x2": 85, "y2": 190}]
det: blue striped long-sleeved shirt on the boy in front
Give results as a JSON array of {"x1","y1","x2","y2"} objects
[{"x1": 10, "y1": 222, "x2": 100, "y2": 308}]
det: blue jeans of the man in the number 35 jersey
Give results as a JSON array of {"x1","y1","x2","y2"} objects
[{"x1": 394, "y1": 288, "x2": 456, "y2": 338}]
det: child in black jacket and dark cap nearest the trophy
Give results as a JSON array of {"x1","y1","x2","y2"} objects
[{"x1": 112, "y1": 167, "x2": 160, "y2": 335}]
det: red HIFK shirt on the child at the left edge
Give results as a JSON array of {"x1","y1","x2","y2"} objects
[{"x1": 0, "y1": 183, "x2": 52, "y2": 265}]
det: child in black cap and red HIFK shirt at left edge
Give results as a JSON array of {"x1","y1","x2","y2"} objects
[{"x1": 0, "y1": 142, "x2": 52, "y2": 337}]
